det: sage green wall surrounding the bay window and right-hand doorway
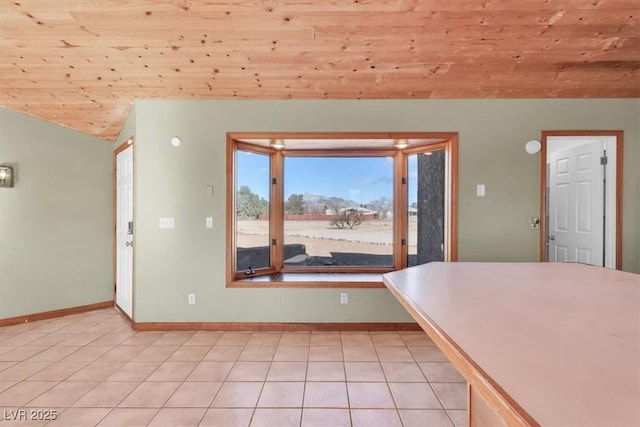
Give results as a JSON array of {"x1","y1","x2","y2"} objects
[{"x1": 132, "y1": 99, "x2": 640, "y2": 322}]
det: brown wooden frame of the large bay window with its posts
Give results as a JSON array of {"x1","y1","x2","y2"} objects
[{"x1": 226, "y1": 132, "x2": 458, "y2": 288}]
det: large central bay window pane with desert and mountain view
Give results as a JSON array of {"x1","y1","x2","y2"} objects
[{"x1": 284, "y1": 157, "x2": 393, "y2": 268}]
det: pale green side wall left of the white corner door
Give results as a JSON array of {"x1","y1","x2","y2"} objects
[{"x1": 0, "y1": 108, "x2": 114, "y2": 318}]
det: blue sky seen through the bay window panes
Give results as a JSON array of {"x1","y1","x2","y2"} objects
[{"x1": 238, "y1": 151, "x2": 416, "y2": 204}]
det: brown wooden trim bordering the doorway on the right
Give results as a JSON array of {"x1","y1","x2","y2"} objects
[{"x1": 540, "y1": 130, "x2": 624, "y2": 270}]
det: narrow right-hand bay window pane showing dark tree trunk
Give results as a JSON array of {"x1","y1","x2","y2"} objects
[{"x1": 407, "y1": 150, "x2": 445, "y2": 266}]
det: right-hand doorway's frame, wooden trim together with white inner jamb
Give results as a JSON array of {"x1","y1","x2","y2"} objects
[{"x1": 540, "y1": 131, "x2": 623, "y2": 270}]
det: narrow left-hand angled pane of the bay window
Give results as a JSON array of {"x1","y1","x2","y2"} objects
[{"x1": 236, "y1": 151, "x2": 271, "y2": 271}]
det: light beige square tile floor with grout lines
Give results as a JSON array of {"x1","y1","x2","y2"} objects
[{"x1": 0, "y1": 309, "x2": 467, "y2": 427}]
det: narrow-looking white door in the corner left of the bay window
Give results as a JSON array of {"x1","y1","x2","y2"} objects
[{"x1": 116, "y1": 145, "x2": 133, "y2": 317}]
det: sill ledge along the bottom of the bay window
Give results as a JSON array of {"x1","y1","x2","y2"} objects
[{"x1": 227, "y1": 273, "x2": 386, "y2": 288}]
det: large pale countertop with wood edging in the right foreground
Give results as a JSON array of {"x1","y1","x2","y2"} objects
[{"x1": 383, "y1": 262, "x2": 640, "y2": 426}]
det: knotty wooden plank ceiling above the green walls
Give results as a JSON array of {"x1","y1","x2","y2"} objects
[{"x1": 0, "y1": 0, "x2": 640, "y2": 140}]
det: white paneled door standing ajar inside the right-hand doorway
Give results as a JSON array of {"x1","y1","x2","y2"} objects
[{"x1": 548, "y1": 141, "x2": 605, "y2": 266}]
